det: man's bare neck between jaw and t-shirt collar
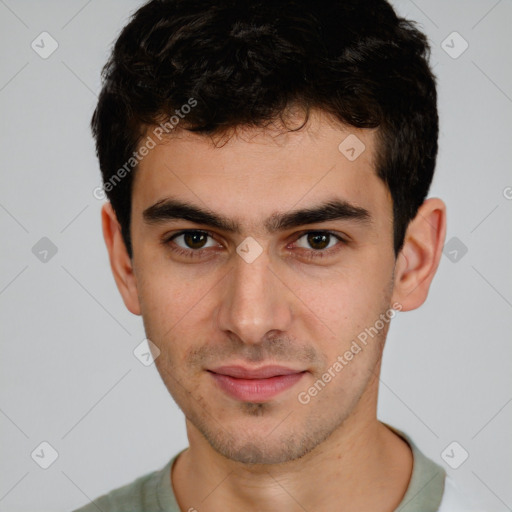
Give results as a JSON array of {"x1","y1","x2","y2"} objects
[{"x1": 172, "y1": 388, "x2": 413, "y2": 512}]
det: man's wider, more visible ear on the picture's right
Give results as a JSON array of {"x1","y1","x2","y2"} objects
[{"x1": 392, "y1": 198, "x2": 446, "y2": 311}]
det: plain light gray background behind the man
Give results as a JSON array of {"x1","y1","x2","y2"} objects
[{"x1": 0, "y1": 0, "x2": 512, "y2": 512}]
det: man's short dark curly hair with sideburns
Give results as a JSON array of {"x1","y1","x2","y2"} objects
[{"x1": 91, "y1": 0, "x2": 439, "y2": 256}]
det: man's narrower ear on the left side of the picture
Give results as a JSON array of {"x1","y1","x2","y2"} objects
[{"x1": 101, "y1": 203, "x2": 140, "y2": 315}]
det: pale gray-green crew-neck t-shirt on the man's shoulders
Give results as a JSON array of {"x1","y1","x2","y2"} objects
[{"x1": 74, "y1": 427, "x2": 446, "y2": 512}]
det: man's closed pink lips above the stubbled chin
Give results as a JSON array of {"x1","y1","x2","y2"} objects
[{"x1": 208, "y1": 366, "x2": 306, "y2": 402}]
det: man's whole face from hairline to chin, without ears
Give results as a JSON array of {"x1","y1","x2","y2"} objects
[{"x1": 126, "y1": 112, "x2": 395, "y2": 464}]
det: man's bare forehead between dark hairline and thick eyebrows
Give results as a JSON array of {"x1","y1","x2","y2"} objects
[{"x1": 132, "y1": 113, "x2": 391, "y2": 225}]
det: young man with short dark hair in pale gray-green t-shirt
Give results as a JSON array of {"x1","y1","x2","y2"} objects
[{"x1": 74, "y1": 0, "x2": 474, "y2": 512}]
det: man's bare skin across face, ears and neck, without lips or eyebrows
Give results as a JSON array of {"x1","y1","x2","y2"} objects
[{"x1": 102, "y1": 111, "x2": 446, "y2": 512}]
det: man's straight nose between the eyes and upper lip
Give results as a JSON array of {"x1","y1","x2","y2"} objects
[{"x1": 218, "y1": 247, "x2": 293, "y2": 344}]
